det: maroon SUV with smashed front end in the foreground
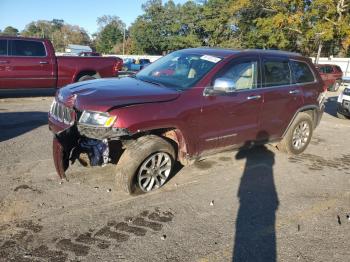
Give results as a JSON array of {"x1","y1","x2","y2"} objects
[{"x1": 49, "y1": 48, "x2": 324, "y2": 193}]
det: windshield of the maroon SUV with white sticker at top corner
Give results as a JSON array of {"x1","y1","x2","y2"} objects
[{"x1": 136, "y1": 52, "x2": 221, "y2": 90}]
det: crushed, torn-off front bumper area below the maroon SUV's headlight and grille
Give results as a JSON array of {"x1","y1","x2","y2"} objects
[{"x1": 49, "y1": 116, "x2": 131, "y2": 179}]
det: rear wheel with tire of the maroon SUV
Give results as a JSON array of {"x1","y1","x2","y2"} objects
[{"x1": 277, "y1": 113, "x2": 313, "y2": 155}]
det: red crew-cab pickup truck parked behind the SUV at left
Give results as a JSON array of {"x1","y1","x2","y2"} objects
[{"x1": 0, "y1": 37, "x2": 123, "y2": 89}]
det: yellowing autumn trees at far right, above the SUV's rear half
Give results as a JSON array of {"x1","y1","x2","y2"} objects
[{"x1": 230, "y1": 0, "x2": 350, "y2": 56}]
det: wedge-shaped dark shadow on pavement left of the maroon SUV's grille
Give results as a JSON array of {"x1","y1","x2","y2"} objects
[{"x1": 0, "y1": 112, "x2": 47, "y2": 142}]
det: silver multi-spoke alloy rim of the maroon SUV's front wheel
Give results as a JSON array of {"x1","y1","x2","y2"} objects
[{"x1": 137, "y1": 152, "x2": 173, "y2": 192}]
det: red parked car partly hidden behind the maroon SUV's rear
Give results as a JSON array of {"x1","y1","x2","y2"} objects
[{"x1": 316, "y1": 64, "x2": 343, "y2": 92}]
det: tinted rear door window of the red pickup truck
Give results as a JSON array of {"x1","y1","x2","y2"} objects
[{"x1": 10, "y1": 40, "x2": 46, "y2": 57}]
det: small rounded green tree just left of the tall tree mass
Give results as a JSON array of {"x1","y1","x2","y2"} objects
[{"x1": 95, "y1": 16, "x2": 125, "y2": 53}]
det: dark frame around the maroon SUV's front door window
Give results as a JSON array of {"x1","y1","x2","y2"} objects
[{"x1": 210, "y1": 55, "x2": 262, "y2": 93}]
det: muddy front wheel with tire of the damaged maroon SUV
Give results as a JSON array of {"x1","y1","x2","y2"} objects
[{"x1": 116, "y1": 135, "x2": 175, "y2": 194}]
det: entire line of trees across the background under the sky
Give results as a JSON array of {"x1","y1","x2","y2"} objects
[{"x1": 1, "y1": 0, "x2": 350, "y2": 56}]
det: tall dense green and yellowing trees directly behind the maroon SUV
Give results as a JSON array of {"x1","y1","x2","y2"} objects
[{"x1": 130, "y1": 0, "x2": 350, "y2": 55}]
